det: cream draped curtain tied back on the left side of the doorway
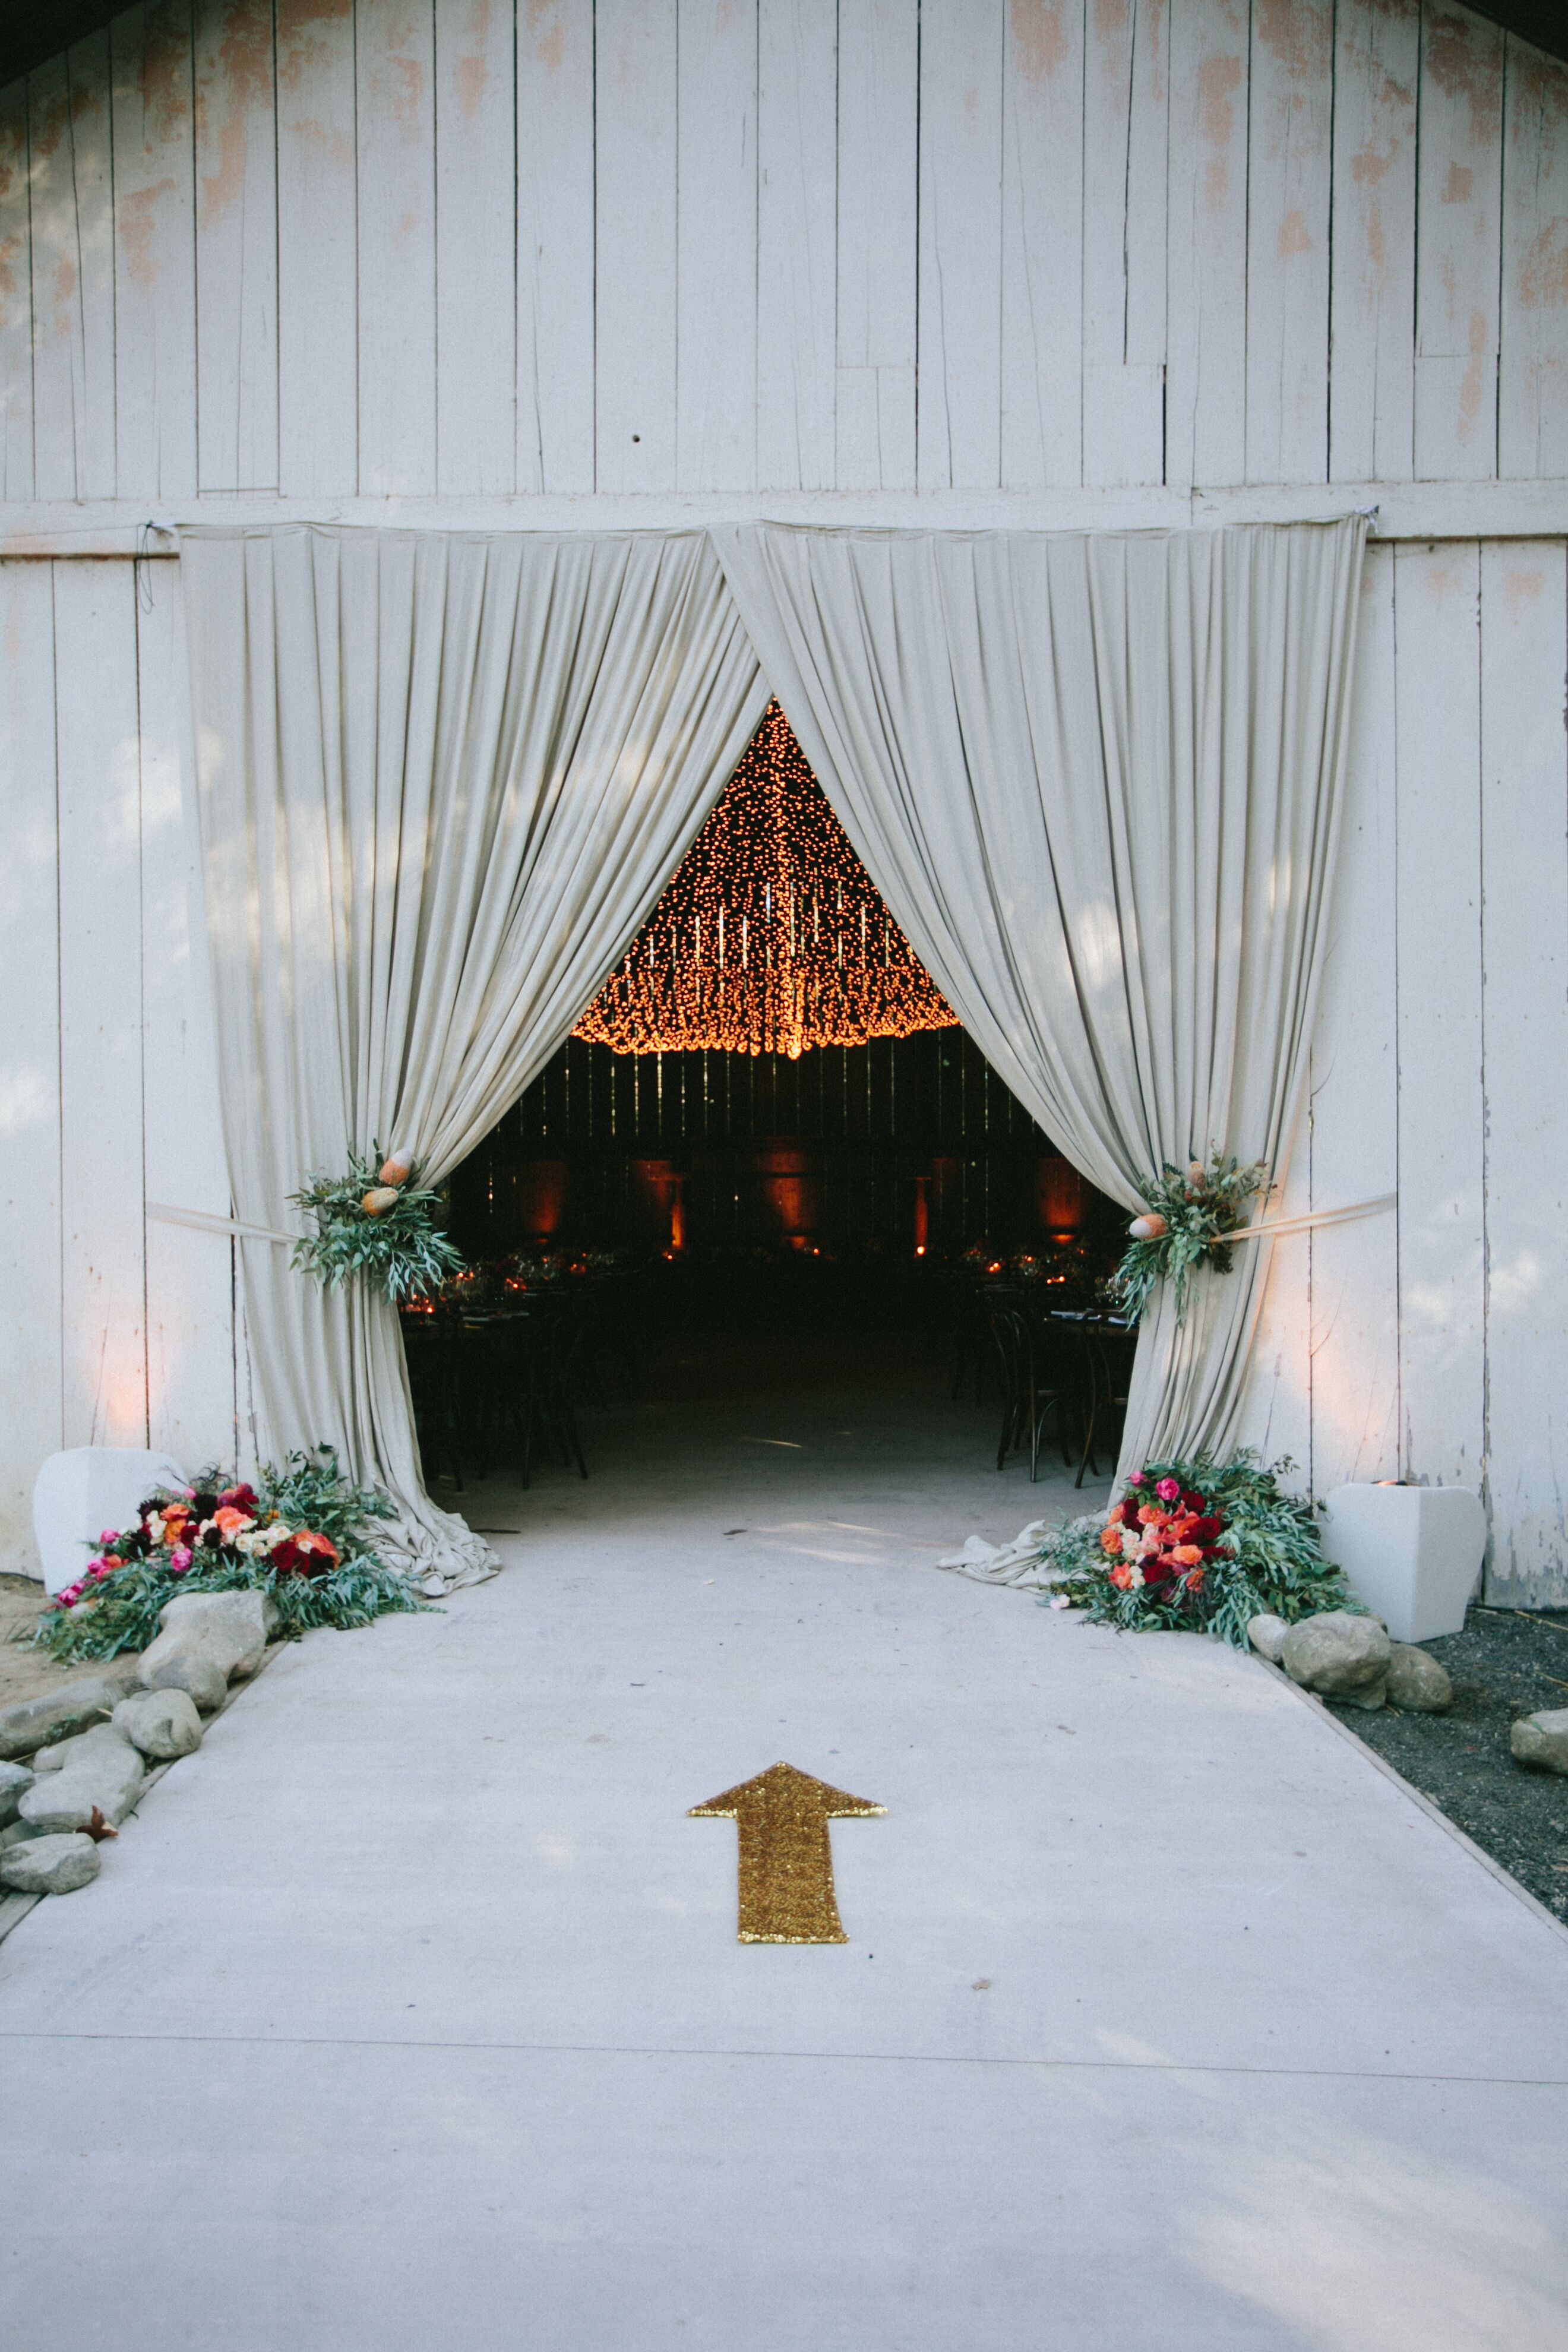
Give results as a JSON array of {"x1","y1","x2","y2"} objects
[{"x1": 181, "y1": 527, "x2": 766, "y2": 1583}]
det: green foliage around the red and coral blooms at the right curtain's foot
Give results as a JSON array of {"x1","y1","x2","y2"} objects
[{"x1": 1041, "y1": 1451, "x2": 1361, "y2": 1649}]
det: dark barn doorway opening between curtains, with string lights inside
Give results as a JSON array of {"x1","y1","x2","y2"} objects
[{"x1": 404, "y1": 703, "x2": 1131, "y2": 1531}]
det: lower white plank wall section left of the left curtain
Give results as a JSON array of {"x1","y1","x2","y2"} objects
[{"x1": 0, "y1": 559, "x2": 242, "y2": 1573}]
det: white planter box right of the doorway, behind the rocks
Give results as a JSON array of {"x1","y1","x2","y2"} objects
[{"x1": 1323, "y1": 1487, "x2": 1485, "y2": 1642}]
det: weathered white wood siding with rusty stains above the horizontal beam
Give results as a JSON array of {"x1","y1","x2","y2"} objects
[{"x1": 0, "y1": 0, "x2": 1568, "y2": 505}]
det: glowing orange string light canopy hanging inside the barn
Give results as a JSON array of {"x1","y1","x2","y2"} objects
[{"x1": 571, "y1": 703, "x2": 957, "y2": 1061}]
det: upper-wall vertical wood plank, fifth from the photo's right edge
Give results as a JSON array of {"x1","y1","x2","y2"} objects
[{"x1": 1166, "y1": 0, "x2": 1248, "y2": 489}]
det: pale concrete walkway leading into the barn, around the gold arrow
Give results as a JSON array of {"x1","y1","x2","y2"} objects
[{"x1": 0, "y1": 1336, "x2": 1568, "y2": 2352}]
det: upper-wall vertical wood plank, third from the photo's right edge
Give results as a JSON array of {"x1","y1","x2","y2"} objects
[{"x1": 1328, "y1": 0, "x2": 1420, "y2": 482}]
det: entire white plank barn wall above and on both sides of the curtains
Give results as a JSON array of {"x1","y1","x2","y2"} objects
[{"x1": 0, "y1": 0, "x2": 1568, "y2": 1597}]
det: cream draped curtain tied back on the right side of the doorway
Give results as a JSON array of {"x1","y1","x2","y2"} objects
[{"x1": 712, "y1": 517, "x2": 1366, "y2": 1468}]
